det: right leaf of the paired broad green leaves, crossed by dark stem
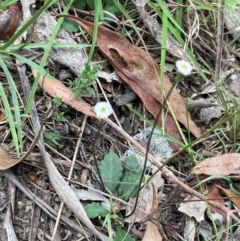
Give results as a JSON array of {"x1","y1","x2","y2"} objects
[{"x1": 118, "y1": 155, "x2": 142, "y2": 201}]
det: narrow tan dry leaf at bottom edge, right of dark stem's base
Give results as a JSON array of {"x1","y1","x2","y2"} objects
[{"x1": 142, "y1": 184, "x2": 162, "y2": 241}]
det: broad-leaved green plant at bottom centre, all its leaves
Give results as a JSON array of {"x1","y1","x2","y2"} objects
[{"x1": 85, "y1": 152, "x2": 142, "y2": 241}]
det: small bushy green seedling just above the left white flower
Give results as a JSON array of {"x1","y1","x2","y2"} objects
[{"x1": 70, "y1": 62, "x2": 99, "y2": 98}]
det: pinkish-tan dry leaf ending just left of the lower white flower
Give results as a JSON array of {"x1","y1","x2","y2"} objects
[{"x1": 32, "y1": 69, "x2": 96, "y2": 117}]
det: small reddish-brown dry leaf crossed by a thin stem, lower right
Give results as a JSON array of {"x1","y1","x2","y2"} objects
[{"x1": 206, "y1": 184, "x2": 227, "y2": 218}]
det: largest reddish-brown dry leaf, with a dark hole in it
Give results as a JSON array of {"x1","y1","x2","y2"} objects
[{"x1": 59, "y1": 15, "x2": 201, "y2": 149}]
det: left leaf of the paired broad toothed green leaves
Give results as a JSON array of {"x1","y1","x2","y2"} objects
[{"x1": 99, "y1": 152, "x2": 123, "y2": 192}]
